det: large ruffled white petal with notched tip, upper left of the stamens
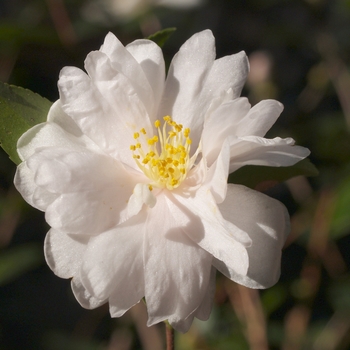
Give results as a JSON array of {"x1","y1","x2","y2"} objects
[{"x1": 58, "y1": 60, "x2": 151, "y2": 170}]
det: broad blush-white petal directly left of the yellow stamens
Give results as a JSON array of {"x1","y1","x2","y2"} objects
[{"x1": 28, "y1": 148, "x2": 140, "y2": 234}]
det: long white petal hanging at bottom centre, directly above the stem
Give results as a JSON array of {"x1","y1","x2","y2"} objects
[{"x1": 144, "y1": 194, "x2": 212, "y2": 332}]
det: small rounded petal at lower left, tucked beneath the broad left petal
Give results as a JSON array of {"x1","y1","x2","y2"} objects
[{"x1": 44, "y1": 229, "x2": 89, "y2": 278}]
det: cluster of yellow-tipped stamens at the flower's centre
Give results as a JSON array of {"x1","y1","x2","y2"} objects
[{"x1": 130, "y1": 116, "x2": 192, "y2": 190}]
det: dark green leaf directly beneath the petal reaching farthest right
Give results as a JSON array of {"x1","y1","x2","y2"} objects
[{"x1": 228, "y1": 158, "x2": 318, "y2": 188}]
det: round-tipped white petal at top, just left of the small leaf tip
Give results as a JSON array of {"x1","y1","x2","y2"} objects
[{"x1": 126, "y1": 40, "x2": 165, "y2": 117}]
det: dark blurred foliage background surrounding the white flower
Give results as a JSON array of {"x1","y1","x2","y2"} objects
[{"x1": 0, "y1": 0, "x2": 350, "y2": 350}]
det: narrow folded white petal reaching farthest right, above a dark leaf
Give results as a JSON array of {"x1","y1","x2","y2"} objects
[{"x1": 230, "y1": 136, "x2": 310, "y2": 173}]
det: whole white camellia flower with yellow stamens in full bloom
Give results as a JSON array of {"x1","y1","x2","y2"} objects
[{"x1": 15, "y1": 30, "x2": 309, "y2": 332}]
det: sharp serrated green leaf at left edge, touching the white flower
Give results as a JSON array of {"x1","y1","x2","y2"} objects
[{"x1": 0, "y1": 82, "x2": 52, "y2": 164}]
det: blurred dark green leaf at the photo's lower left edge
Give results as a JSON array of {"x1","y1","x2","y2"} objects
[{"x1": 0, "y1": 243, "x2": 44, "y2": 285}]
